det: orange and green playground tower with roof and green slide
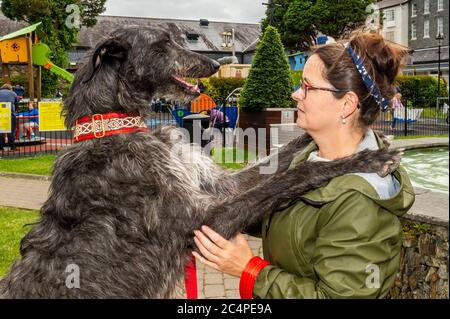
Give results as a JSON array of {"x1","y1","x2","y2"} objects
[{"x1": 0, "y1": 22, "x2": 74, "y2": 101}]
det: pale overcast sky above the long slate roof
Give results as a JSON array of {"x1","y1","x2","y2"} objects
[{"x1": 103, "y1": 0, "x2": 268, "y2": 23}]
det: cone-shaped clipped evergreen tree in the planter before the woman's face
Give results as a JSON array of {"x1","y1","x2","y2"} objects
[{"x1": 240, "y1": 26, "x2": 294, "y2": 111}]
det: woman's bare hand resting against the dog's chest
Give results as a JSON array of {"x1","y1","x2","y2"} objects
[{"x1": 193, "y1": 226, "x2": 253, "y2": 277}]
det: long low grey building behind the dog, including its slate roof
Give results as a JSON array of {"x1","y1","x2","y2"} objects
[{"x1": 0, "y1": 12, "x2": 261, "y2": 69}]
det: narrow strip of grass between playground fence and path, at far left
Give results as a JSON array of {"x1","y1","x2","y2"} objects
[{"x1": 0, "y1": 155, "x2": 56, "y2": 175}]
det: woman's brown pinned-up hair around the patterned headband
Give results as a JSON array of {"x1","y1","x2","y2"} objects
[{"x1": 313, "y1": 31, "x2": 411, "y2": 127}]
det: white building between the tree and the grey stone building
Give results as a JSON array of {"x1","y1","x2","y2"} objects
[{"x1": 377, "y1": 0, "x2": 409, "y2": 46}]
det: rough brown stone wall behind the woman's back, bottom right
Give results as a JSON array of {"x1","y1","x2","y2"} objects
[{"x1": 389, "y1": 215, "x2": 449, "y2": 299}]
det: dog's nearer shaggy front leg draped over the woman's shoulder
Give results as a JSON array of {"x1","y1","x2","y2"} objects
[{"x1": 198, "y1": 149, "x2": 400, "y2": 239}]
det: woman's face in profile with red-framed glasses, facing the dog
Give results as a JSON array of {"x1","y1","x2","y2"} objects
[{"x1": 292, "y1": 54, "x2": 343, "y2": 133}]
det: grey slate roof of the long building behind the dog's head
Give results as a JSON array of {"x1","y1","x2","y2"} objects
[{"x1": 77, "y1": 15, "x2": 261, "y2": 52}]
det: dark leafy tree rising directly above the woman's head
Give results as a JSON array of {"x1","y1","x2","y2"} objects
[{"x1": 262, "y1": 0, "x2": 375, "y2": 51}]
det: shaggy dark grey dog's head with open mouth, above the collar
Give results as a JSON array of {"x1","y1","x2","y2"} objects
[{"x1": 65, "y1": 26, "x2": 220, "y2": 125}]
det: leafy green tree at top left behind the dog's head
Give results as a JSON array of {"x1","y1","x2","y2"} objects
[{"x1": 1, "y1": 0, "x2": 106, "y2": 97}]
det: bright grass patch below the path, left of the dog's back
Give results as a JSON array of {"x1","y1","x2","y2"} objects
[{"x1": 0, "y1": 207, "x2": 39, "y2": 278}]
